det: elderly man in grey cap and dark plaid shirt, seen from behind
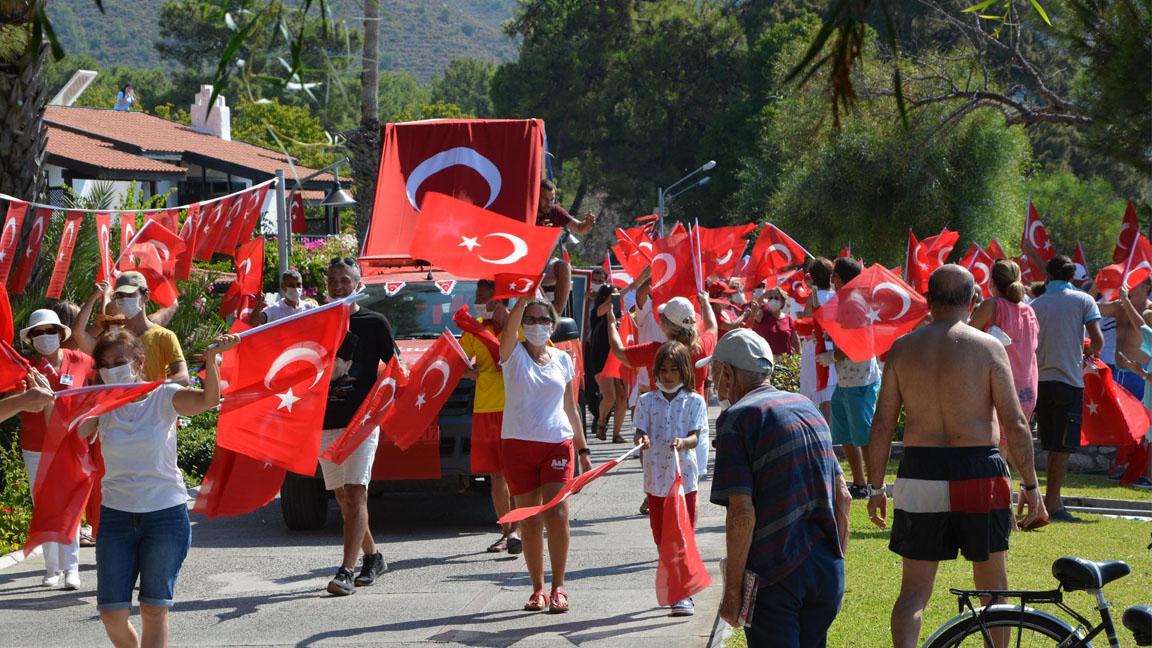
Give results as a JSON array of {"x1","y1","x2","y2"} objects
[{"x1": 697, "y1": 329, "x2": 851, "y2": 648}]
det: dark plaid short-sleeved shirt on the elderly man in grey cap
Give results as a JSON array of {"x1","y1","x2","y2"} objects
[{"x1": 711, "y1": 385, "x2": 843, "y2": 587}]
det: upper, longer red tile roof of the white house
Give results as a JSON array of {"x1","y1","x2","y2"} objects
[{"x1": 44, "y1": 106, "x2": 333, "y2": 182}]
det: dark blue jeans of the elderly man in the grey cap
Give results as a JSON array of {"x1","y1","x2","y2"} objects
[{"x1": 741, "y1": 539, "x2": 844, "y2": 648}]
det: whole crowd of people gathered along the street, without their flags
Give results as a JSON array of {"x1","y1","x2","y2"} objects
[{"x1": 0, "y1": 183, "x2": 1152, "y2": 646}]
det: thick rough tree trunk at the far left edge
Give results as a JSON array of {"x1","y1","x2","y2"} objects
[{"x1": 0, "y1": 2, "x2": 48, "y2": 201}]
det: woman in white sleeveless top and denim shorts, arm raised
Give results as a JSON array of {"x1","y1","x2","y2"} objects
[{"x1": 79, "y1": 331, "x2": 240, "y2": 646}]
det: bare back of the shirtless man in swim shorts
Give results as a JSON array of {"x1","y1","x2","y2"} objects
[{"x1": 878, "y1": 322, "x2": 1023, "y2": 447}]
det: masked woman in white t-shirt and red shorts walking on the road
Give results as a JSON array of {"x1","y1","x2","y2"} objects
[{"x1": 500, "y1": 299, "x2": 592, "y2": 612}]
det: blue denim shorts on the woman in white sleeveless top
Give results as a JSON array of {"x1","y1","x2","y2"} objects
[{"x1": 96, "y1": 504, "x2": 192, "y2": 611}]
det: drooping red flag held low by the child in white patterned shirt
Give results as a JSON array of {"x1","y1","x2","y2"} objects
[{"x1": 655, "y1": 461, "x2": 712, "y2": 605}]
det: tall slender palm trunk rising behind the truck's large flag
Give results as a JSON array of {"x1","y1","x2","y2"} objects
[{"x1": 347, "y1": 0, "x2": 382, "y2": 248}]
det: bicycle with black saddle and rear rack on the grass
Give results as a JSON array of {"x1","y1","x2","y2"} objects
[{"x1": 924, "y1": 557, "x2": 1152, "y2": 648}]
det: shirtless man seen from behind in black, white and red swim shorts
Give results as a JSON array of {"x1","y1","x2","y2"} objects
[{"x1": 866, "y1": 264, "x2": 1047, "y2": 648}]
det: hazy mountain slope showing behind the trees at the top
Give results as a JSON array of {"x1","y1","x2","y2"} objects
[{"x1": 46, "y1": 0, "x2": 516, "y2": 82}]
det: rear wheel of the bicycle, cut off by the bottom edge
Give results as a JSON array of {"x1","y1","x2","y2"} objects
[{"x1": 924, "y1": 605, "x2": 1091, "y2": 648}]
